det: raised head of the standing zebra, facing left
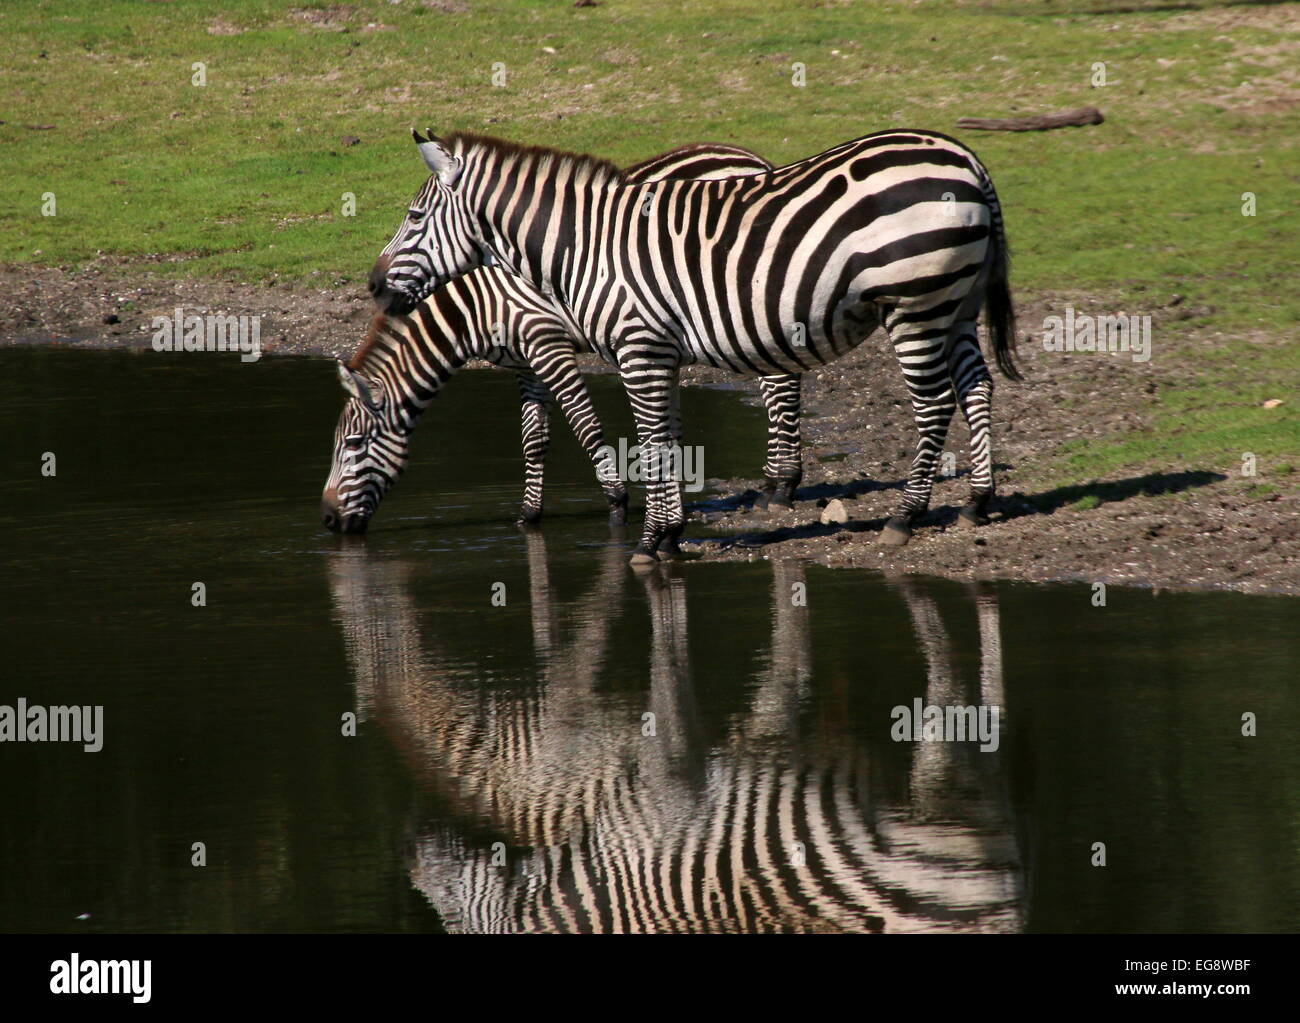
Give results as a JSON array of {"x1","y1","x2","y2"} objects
[{"x1": 371, "y1": 131, "x2": 489, "y2": 315}]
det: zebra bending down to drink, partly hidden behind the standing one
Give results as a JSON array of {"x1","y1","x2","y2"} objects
[{"x1": 321, "y1": 143, "x2": 802, "y2": 533}]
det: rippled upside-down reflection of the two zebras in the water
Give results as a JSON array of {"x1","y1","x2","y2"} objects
[{"x1": 330, "y1": 548, "x2": 1024, "y2": 933}]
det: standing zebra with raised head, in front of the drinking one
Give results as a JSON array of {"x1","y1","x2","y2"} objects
[{"x1": 371, "y1": 129, "x2": 1019, "y2": 564}]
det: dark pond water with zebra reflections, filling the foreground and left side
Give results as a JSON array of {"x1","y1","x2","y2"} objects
[{"x1": 0, "y1": 350, "x2": 1300, "y2": 932}]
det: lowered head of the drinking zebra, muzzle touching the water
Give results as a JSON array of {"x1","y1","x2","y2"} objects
[{"x1": 321, "y1": 361, "x2": 411, "y2": 533}]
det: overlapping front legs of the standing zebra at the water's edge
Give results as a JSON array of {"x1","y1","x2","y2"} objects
[{"x1": 618, "y1": 343, "x2": 685, "y2": 565}]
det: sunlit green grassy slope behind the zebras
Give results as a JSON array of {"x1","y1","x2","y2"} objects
[{"x1": 0, "y1": 0, "x2": 1300, "y2": 478}]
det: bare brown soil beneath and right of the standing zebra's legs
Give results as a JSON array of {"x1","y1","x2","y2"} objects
[{"x1": 685, "y1": 294, "x2": 1300, "y2": 594}]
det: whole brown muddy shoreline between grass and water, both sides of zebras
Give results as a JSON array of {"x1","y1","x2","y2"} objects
[{"x1": 0, "y1": 263, "x2": 1300, "y2": 594}]
